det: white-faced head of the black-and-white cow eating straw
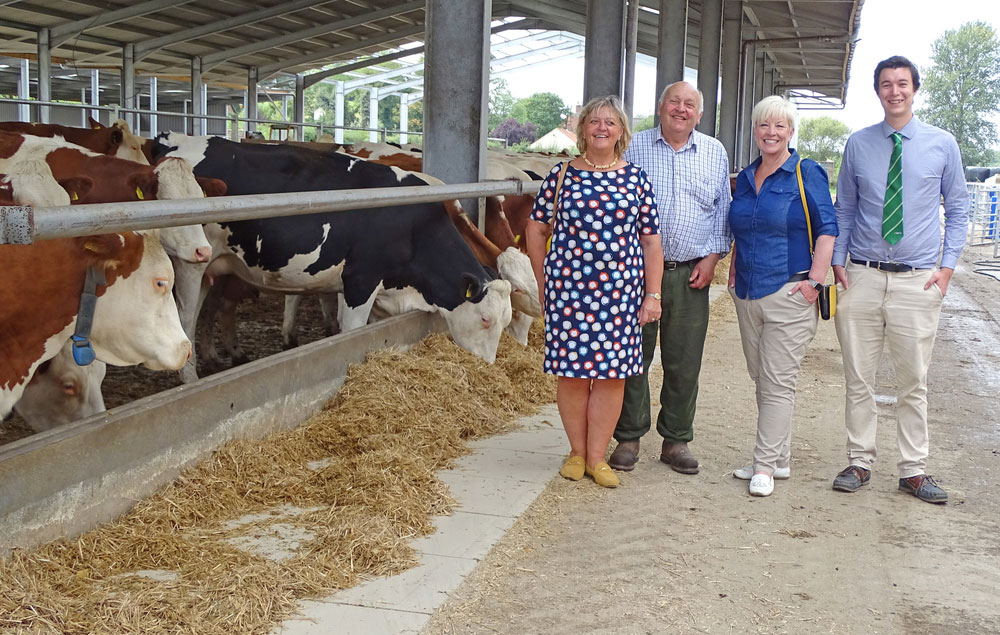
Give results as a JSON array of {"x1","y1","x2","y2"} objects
[{"x1": 440, "y1": 279, "x2": 511, "y2": 364}]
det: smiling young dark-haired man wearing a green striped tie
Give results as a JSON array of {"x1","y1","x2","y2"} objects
[{"x1": 833, "y1": 56, "x2": 969, "y2": 503}]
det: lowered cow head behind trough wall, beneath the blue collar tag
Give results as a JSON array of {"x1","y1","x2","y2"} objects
[{"x1": 14, "y1": 342, "x2": 107, "y2": 432}]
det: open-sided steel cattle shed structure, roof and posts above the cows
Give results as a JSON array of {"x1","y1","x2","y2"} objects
[{"x1": 0, "y1": 0, "x2": 863, "y2": 182}]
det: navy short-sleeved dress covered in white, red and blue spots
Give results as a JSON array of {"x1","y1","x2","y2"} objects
[{"x1": 532, "y1": 163, "x2": 660, "y2": 379}]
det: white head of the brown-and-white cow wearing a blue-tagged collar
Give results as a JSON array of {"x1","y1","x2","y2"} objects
[{"x1": 90, "y1": 231, "x2": 191, "y2": 370}]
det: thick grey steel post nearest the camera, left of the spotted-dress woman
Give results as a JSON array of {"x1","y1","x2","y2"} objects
[{"x1": 424, "y1": 0, "x2": 492, "y2": 225}]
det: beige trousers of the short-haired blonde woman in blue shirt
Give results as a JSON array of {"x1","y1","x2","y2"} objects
[{"x1": 729, "y1": 282, "x2": 819, "y2": 474}]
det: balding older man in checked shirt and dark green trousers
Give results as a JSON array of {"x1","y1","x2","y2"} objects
[{"x1": 608, "y1": 82, "x2": 733, "y2": 474}]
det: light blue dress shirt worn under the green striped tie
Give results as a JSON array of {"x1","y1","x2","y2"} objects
[{"x1": 833, "y1": 117, "x2": 969, "y2": 269}]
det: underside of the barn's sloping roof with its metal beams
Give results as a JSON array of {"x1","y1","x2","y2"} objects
[{"x1": 0, "y1": 0, "x2": 863, "y2": 105}]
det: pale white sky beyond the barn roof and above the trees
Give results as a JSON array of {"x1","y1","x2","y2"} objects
[{"x1": 503, "y1": 0, "x2": 1000, "y2": 130}]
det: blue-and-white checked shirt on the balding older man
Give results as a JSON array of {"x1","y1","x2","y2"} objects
[{"x1": 625, "y1": 126, "x2": 733, "y2": 262}]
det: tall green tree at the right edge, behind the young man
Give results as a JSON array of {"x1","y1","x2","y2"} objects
[{"x1": 918, "y1": 21, "x2": 1000, "y2": 165}]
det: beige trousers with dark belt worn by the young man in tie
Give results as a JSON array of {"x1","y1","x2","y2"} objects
[{"x1": 835, "y1": 262, "x2": 942, "y2": 478}]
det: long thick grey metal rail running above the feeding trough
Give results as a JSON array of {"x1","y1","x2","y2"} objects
[{"x1": 0, "y1": 181, "x2": 541, "y2": 244}]
